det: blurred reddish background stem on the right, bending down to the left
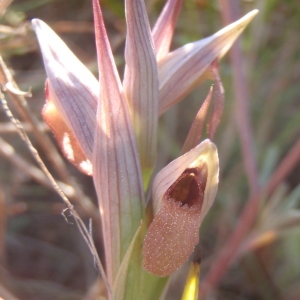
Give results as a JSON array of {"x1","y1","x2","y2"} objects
[{"x1": 200, "y1": 0, "x2": 260, "y2": 299}]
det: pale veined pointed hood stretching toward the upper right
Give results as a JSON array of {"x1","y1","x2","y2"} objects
[{"x1": 158, "y1": 10, "x2": 258, "y2": 114}]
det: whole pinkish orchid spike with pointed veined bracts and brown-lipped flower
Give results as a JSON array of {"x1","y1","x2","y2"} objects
[{"x1": 32, "y1": 0, "x2": 257, "y2": 299}]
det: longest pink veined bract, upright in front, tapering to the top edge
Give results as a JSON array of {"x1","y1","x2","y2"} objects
[{"x1": 92, "y1": 0, "x2": 145, "y2": 284}]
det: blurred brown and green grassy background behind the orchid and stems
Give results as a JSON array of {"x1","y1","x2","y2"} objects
[{"x1": 0, "y1": 0, "x2": 300, "y2": 300}]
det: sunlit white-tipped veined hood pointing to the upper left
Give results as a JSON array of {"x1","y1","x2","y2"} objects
[{"x1": 32, "y1": 19, "x2": 99, "y2": 161}]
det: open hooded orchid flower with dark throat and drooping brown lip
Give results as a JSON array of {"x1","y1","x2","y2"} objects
[{"x1": 143, "y1": 140, "x2": 219, "y2": 276}]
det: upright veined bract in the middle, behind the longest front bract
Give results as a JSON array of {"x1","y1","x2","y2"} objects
[{"x1": 123, "y1": 0, "x2": 159, "y2": 190}]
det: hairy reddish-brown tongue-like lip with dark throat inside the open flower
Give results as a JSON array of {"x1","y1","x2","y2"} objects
[{"x1": 143, "y1": 162, "x2": 208, "y2": 276}]
